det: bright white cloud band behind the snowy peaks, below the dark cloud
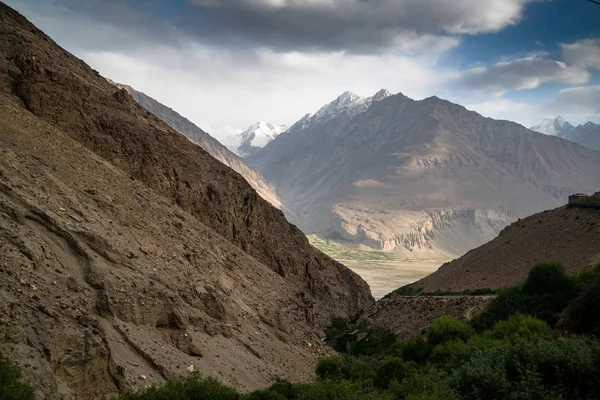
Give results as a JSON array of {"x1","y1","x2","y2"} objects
[{"x1": 78, "y1": 43, "x2": 450, "y2": 136}]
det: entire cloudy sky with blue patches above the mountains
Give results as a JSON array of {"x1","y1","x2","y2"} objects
[{"x1": 4, "y1": 0, "x2": 600, "y2": 139}]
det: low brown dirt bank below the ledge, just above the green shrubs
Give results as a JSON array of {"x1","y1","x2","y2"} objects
[{"x1": 362, "y1": 293, "x2": 493, "y2": 340}]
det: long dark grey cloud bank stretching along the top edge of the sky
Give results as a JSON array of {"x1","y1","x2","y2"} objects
[{"x1": 9, "y1": 0, "x2": 531, "y2": 53}]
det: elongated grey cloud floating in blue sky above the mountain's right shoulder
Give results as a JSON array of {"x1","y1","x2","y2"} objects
[{"x1": 460, "y1": 57, "x2": 590, "y2": 95}]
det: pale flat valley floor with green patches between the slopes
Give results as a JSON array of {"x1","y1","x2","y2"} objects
[{"x1": 308, "y1": 235, "x2": 442, "y2": 300}]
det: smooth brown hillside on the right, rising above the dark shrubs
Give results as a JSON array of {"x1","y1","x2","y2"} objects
[{"x1": 413, "y1": 206, "x2": 600, "y2": 292}]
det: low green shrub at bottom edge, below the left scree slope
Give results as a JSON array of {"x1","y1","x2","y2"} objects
[{"x1": 118, "y1": 375, "x2": 240, "y2": 400}]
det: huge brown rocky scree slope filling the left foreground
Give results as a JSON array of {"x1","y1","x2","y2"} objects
[{"x1": 0, "y1": 3, "x2": 372, "y2": 399}]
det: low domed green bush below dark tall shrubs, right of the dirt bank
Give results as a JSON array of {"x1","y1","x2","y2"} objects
[{"x1": 486, "y1": 314, "x2": 552, "y2": 341}]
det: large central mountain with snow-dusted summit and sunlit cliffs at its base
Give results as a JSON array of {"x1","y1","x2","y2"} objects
[{"x1": 248, "y1": 91, "x2": 600, "y2": 258}]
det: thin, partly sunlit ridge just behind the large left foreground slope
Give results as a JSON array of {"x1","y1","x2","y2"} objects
[{"x1": 109, "y1": 80, "x2": 281, "y2": 208}]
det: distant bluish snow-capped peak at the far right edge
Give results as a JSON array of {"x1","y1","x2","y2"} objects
[{"x1": 529, "y1": 116, "x2": 600, "y2": 151}]
